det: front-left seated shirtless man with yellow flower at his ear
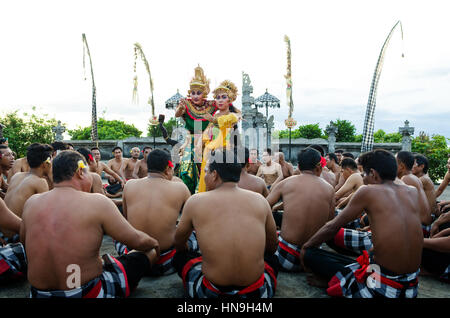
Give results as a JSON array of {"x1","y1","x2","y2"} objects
[{"x1": 20, "y1": 150, "x2": 159, "y2": 298}]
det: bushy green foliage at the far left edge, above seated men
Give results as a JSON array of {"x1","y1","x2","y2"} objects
[{"x1": 0, "y1": 107, "x2": 58, "y2": 158}]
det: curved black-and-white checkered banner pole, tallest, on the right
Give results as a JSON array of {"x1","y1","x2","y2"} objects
[{"x1": 361, "y1": 21, "x2": 405, "y2": 152}]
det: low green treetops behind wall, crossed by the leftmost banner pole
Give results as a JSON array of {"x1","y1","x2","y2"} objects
[{"x1": 68, "y1": 118, "x2": 142, "y2": 140}]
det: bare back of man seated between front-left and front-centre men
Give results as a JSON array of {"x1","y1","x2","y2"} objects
[{"x1": 123, "y1": 178, "x2": 190, "y2": 250}]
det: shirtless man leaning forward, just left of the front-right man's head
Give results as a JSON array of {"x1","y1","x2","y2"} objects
[{"x1": 336, "y1": 158, "x2": 364, "y2": 209}]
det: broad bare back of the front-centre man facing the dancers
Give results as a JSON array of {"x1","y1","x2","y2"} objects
[{"x1": 177, "y1": 185, "x2": 277, "y2": 286}]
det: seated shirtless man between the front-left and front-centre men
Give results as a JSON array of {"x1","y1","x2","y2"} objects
[{"x1": 115, "y1": 149, "x2": 191, "y2": 275}]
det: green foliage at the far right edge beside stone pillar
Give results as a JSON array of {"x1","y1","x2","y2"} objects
[{"x1": 411, "y1": 132, "x2": 450, "y2": 182}]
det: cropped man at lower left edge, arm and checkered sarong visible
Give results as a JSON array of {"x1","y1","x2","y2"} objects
[{"x1": 0, "y1": 199, "x2": 27, "y2": 286}]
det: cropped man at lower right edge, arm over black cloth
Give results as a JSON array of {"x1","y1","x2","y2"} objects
[{"x1": 421, "y1": 213, "x2": 450, "y2": 283}]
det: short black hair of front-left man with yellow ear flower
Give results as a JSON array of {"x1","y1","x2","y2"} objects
[{"x1": 52, "y1": 150, "x2": 86, "y2": 183}]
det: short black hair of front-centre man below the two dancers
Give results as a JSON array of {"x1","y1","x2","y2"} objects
[{"x1": 208, "y1": 149, "x2": 241, "y2": 182}]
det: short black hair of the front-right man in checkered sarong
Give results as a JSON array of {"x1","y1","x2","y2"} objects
[{"x1": 358, "y1": 149, "x2": 397, "y2": 181}]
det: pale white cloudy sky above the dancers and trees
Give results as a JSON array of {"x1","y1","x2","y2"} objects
[{"x1": 0, "y1": 0, "x2": 450, "y2": 138}]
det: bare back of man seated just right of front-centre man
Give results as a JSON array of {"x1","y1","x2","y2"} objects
[{"x1": 267, "y1": 171, "x2": 335, "y2": 247}]
